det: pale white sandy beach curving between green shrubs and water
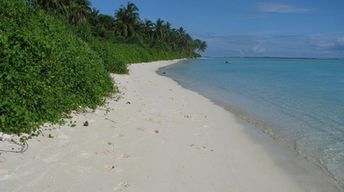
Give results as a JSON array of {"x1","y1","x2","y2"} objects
[{"x1": 0, "y1": 61, "x2": 337, "y2": 192}]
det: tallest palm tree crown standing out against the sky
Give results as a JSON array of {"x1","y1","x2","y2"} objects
[{"x1": 115, "y1": 2, "x2": 140, "y2": 38}]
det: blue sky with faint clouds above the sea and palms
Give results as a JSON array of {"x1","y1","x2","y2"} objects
[{"x1": 91, "y1": 0, "x2": 344, "y2": 58}]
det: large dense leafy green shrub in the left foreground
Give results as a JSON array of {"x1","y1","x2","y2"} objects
[{"x1": 0, "y1": 0, "x2": 113, "y2": 134}]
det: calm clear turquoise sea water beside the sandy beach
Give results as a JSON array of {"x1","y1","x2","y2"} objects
[{"x1": 161, "y1": 58, "x2": 344, "y2": 185}]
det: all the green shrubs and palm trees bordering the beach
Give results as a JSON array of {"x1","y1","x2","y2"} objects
[{"x1": 0, "y1": 0, "x2": 206, "y2": 134}]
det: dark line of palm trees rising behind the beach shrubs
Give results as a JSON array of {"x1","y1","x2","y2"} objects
[{"x1": 29, "y1": 0, "x2": 207, "y2": 57}]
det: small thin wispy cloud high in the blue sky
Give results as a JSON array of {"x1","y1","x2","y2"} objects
[{"x1": 258, "y1": 3, "x2": 315, "y2": 13}]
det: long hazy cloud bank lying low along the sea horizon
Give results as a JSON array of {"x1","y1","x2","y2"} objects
[{"x1": 197, "y1": 33, "x2": 344, "y2": 58}]
